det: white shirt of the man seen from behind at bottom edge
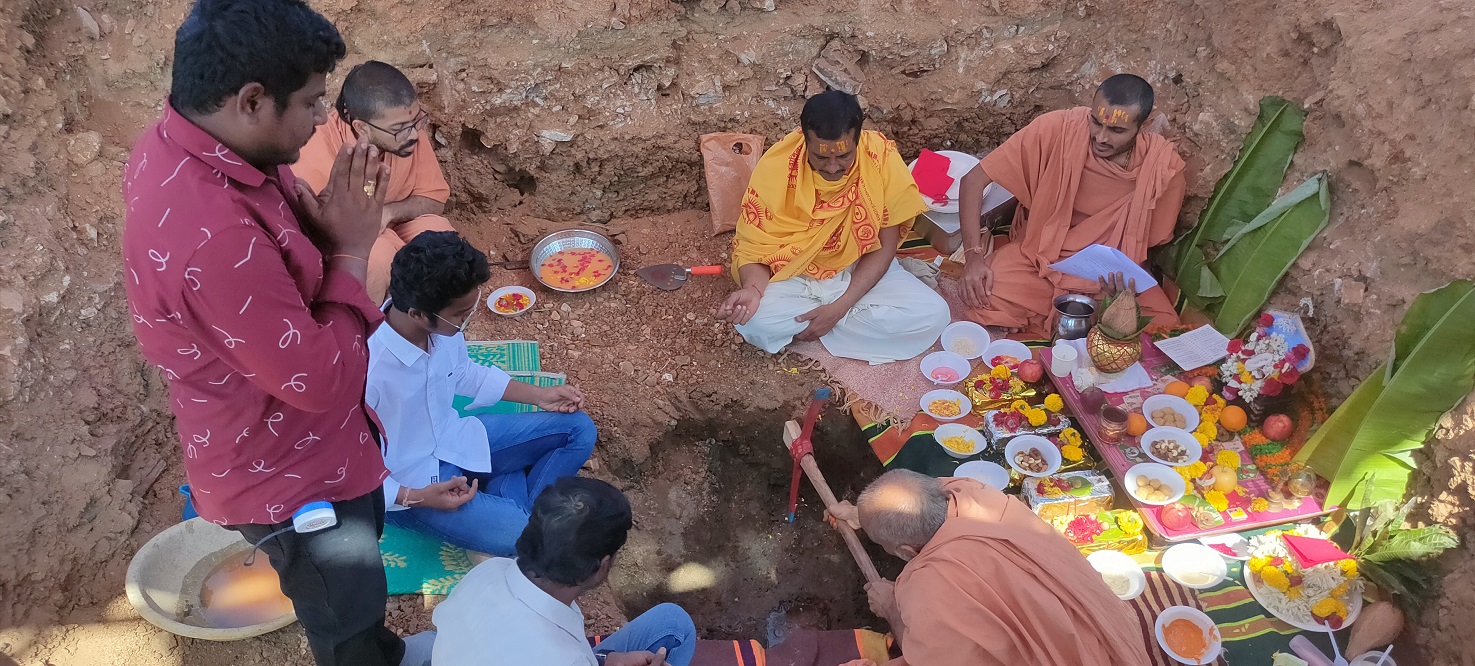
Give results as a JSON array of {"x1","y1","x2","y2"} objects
[{"x1": 431, "y1": 557, "x2": 599, "y2": 666}]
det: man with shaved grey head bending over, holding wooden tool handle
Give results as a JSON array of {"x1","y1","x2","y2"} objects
[{"x1": 830, "y1": 470, "x2": 1149, "y2": 666}]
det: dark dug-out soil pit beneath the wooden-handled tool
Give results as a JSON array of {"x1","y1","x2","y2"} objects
[{"x1": 611, "y1": 411, "x2": 901, "y2": 644}]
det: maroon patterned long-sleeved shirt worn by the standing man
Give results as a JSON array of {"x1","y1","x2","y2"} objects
[{"x1": 122, "y1": 106, "x2": 388, "y2": 525}]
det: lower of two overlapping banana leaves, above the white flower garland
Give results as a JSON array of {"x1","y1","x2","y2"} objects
[{"x1": 1208, "y1": 172, "x2": 1330, "y2": 336}]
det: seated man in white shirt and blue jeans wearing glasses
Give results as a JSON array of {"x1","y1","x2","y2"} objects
[{"x1": 364, "y1": 231, "x2": 596, "y2": 555}]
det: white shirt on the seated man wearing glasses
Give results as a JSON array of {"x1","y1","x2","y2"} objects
[{"x1": 364, "y1": 323, "x2": 512, "y2": 511}]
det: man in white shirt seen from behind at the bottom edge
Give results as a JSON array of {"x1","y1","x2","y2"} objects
[{"x1": 431, "y1": 477, "x2": 696, "y2": 666}]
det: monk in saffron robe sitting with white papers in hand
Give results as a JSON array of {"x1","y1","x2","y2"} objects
[{"x1": 959, "y1": 74, "x2": 1186, "y2": 339}]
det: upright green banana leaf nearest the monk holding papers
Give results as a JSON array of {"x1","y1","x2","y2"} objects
[{"x1": 1170, "y1": 97, "x2": 1305, "y2": 278}]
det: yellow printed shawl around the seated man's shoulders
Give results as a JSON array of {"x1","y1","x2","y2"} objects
[{"x1": 732, "y1": 130, "x2": 926, "y2": 281}]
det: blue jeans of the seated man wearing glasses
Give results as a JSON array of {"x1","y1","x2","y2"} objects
[{"x1": 385, "y1": 411, "x2": 597, "y2": 557}]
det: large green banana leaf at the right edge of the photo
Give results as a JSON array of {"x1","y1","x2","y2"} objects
[{"x1": 1297, "y1": 280, "x2": 1475, "y2": 508}]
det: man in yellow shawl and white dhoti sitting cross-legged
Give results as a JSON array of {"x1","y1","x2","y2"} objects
[{"x1": 718, "y1": 90, "x2": 950, "y2": 362}]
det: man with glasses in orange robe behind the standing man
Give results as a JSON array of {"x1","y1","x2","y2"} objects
[{"x1": 292, "y1": 60, "x2": 454, "y2": 304}]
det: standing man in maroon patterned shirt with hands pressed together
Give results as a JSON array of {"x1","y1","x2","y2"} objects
[{"x1": 122, "y1": 0, "x2": 459, "y2": 666}]
